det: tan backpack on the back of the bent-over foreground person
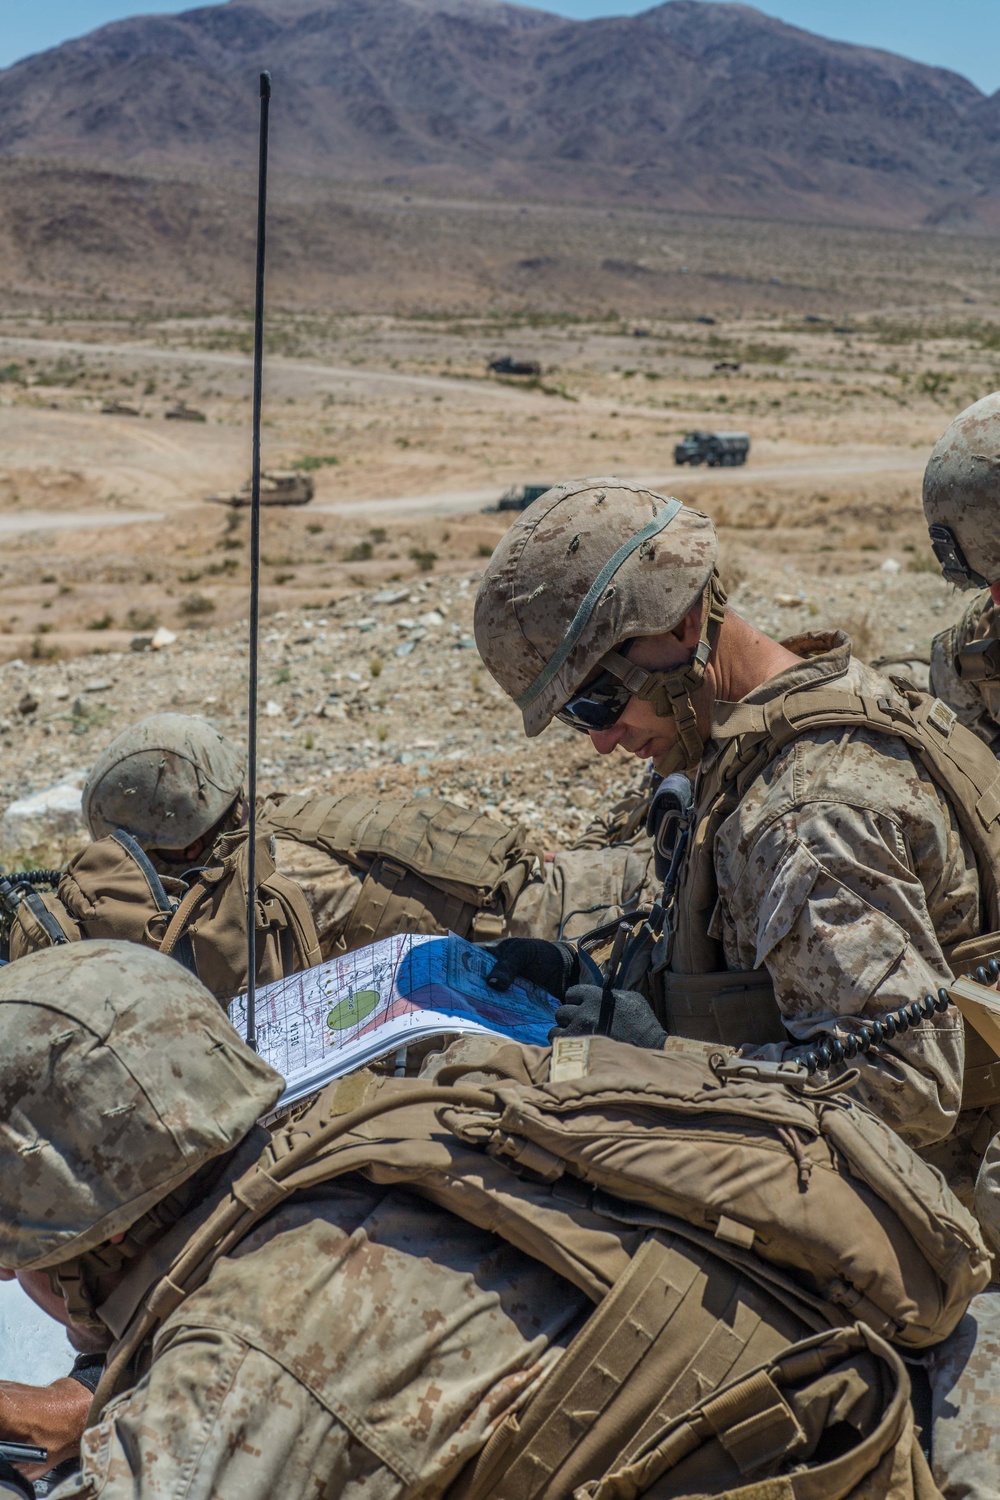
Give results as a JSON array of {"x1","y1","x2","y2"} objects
[{"x1": 88, "y1": 1037, "x2": 990, "y2": 1440}]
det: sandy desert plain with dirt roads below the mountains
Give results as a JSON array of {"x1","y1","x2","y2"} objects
[{"x1": 0, "y1": 191, "x2": 1000, "y2": 867}]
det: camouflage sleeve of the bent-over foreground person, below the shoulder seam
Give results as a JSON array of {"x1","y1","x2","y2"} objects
[{"x1": 52, "y1": 1329, "x2": 408, "y2": 1500}]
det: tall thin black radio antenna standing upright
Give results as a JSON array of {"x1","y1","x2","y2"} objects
[{"x1": 246, "y1": 72, "x2": 271, "y2": 1052}]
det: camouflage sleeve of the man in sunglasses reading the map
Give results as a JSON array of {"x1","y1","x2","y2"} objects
[{"x1": 723, "y1": 803, "x2": 964, "y2": 1146}]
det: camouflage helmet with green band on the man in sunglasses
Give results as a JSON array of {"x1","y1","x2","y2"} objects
[{"x1": 475, "y1": 479, "x2": 718, "y2": 737}]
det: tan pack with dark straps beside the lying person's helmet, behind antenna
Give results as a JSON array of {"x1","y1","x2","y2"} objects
[{"x1": 10, "y1": 830, "x2": 321, "y2": 1002}]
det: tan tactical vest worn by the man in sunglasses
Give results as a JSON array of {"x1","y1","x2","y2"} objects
[{"x1": 655, "y1": 681, "x2": 1000, "y2": 1109}]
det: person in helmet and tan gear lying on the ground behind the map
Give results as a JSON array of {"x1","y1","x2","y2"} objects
[{"x1": 1, "y1": 714, "x2": 651, "y2": 999}]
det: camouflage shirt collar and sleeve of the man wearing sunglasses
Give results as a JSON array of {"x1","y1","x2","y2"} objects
[{"x1": 678, "y1": 636, "x2": 979, "y2": 1146}]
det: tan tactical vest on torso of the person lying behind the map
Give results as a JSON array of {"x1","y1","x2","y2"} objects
[{"x1": 261, "y1": 794, "x2": 541, "y2": 953}]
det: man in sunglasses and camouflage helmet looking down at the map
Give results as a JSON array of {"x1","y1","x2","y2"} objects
[{"x1": 475, "y1": 479, "x2": 1000, "y2": 1494}]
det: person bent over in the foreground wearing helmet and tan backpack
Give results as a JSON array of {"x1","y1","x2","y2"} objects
[{"x1": 0, "y1": 941, "x2": 987, "y2": 1500}]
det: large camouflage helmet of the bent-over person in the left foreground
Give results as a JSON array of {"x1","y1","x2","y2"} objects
[{"x1": 0, "y1": 942, "x2": 285, "y2": 1271}]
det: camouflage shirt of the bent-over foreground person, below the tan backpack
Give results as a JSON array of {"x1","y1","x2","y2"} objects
[{"x1": 55, "y1": 1170, "x2": 589, "y2": 1500}]
